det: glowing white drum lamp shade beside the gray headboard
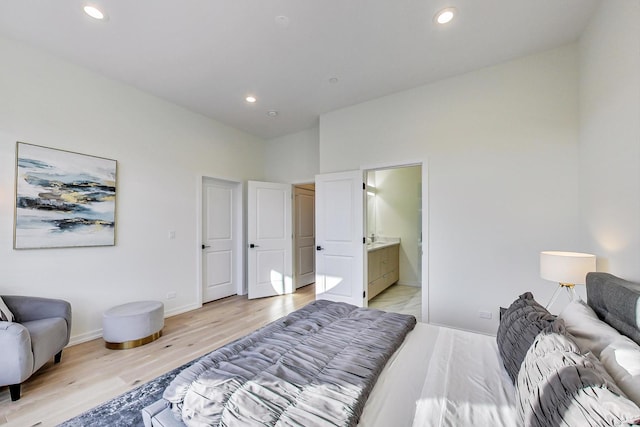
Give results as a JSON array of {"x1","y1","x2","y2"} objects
[{"x1": 540, "y1": 251, "x2": 596, "y2": 285}]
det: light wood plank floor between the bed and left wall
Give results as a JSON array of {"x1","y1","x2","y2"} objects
[{"x1": 0, "y1": 285, "x2": 315, "y2": 427}]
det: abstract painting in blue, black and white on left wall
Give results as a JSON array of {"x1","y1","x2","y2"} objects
[{"x1": 13, "y1": 142, "x2": 117, "y2": 249}]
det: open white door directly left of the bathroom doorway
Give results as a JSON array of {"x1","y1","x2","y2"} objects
[{"x1": 316, "y1": 171, "x2": 366, "y2": 307}]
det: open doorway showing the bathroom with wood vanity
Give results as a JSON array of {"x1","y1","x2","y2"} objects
[{"x1": 365, "y1": 165, "x2": 422, "y2": 321}]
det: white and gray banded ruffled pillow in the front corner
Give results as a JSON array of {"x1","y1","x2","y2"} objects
[{"x1": 516, "y1": 320, "x2": 640, "y2": 427}]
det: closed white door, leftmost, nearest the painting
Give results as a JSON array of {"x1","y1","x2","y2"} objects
[{"x1": 202, "y1": 178, "x2": 241, "y2": 303}]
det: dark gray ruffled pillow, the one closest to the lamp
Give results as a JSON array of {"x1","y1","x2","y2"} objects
[{"x1": 496, "y1": 292, "x2": 555, "y2": 384}]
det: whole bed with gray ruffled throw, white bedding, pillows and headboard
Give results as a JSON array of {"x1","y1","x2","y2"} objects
[{"x1": 143, "y1": 273, "x2": 640, "y2": 427}]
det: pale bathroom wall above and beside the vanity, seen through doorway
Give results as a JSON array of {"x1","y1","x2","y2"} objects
[{"x1": 375, "y1": 166, "x2": 422, "y2": 287}]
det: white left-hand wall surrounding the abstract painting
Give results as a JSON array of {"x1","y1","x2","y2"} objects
[{"x1": 0, "y1": 39, "x2": 264, "y2": 342}]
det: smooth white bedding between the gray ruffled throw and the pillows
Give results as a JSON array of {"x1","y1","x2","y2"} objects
[{"x1": 358, "y1": 323, "x2": 516, "y2": 427}]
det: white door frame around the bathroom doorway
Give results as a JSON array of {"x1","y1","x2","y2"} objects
[{"x1": 360, "y1": 160, "x2": 430, "y2": 323}]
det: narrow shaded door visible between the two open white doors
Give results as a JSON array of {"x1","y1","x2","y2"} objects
[{"x1": 293, "y1": 184, "x2": 316, "y2": 289}]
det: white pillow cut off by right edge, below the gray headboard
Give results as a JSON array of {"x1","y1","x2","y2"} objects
[{"x1": 600, "y1": 335, "x2": 640, "y2": 406}]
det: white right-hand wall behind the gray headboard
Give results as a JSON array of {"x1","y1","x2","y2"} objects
[{"x1": 580, "y1": 0, "x2": 640, "y2": 282}]
